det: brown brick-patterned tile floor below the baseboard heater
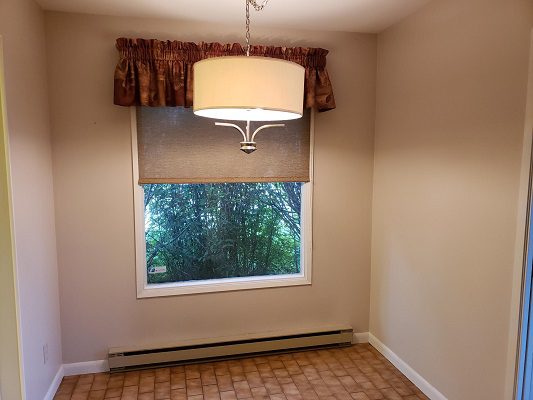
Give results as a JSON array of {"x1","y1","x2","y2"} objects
[{"x1": 54, "y1": 344, "x2": 428, "y2": 400}]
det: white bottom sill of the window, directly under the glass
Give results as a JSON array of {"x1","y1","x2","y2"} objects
[{"x1": 137, "y1": 274, "x2": 311, "y2": 299}]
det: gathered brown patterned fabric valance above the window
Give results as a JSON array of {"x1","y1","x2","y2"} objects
[{"x1": 114, "y1": 38, "x2": 335, "y2": 111}]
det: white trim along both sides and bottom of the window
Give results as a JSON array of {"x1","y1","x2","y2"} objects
[{"x1": 130, "y1": 107, "x2": 315, "y2": 299}]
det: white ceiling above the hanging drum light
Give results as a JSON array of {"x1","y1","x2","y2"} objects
[{"x1": 37, "y1": 0, "x2": 429, "y2": 33}]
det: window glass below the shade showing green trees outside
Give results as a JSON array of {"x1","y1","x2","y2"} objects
[{"x1": 144, "y1": 182, "x2": 302, "y2": 284}]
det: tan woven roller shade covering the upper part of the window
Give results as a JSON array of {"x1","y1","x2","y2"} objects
[{"x1": 137, "y1": 107, "x2": 310, "y2": 184}]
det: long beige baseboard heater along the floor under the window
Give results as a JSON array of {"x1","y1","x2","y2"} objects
[{"x1": 108, "y1": 327, "x2": 353, "y2": 372}]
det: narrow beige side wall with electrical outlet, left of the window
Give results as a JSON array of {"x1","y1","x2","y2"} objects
[{"x1": 0, "y1": 0, "x2": 61, "y2": 400}]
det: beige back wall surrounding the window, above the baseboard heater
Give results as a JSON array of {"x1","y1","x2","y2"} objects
[{"x1": 46, "y1": 13, "x2": 376, "y2": 363}]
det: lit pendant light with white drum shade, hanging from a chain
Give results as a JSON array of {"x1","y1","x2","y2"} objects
[{"x1": 193, "y1": 0, "x2": 305, "y2": 154}]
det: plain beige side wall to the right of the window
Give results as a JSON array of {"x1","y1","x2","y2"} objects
[{"x1": 370, "y1": 0, "x2": 533, "y2": 400}]
